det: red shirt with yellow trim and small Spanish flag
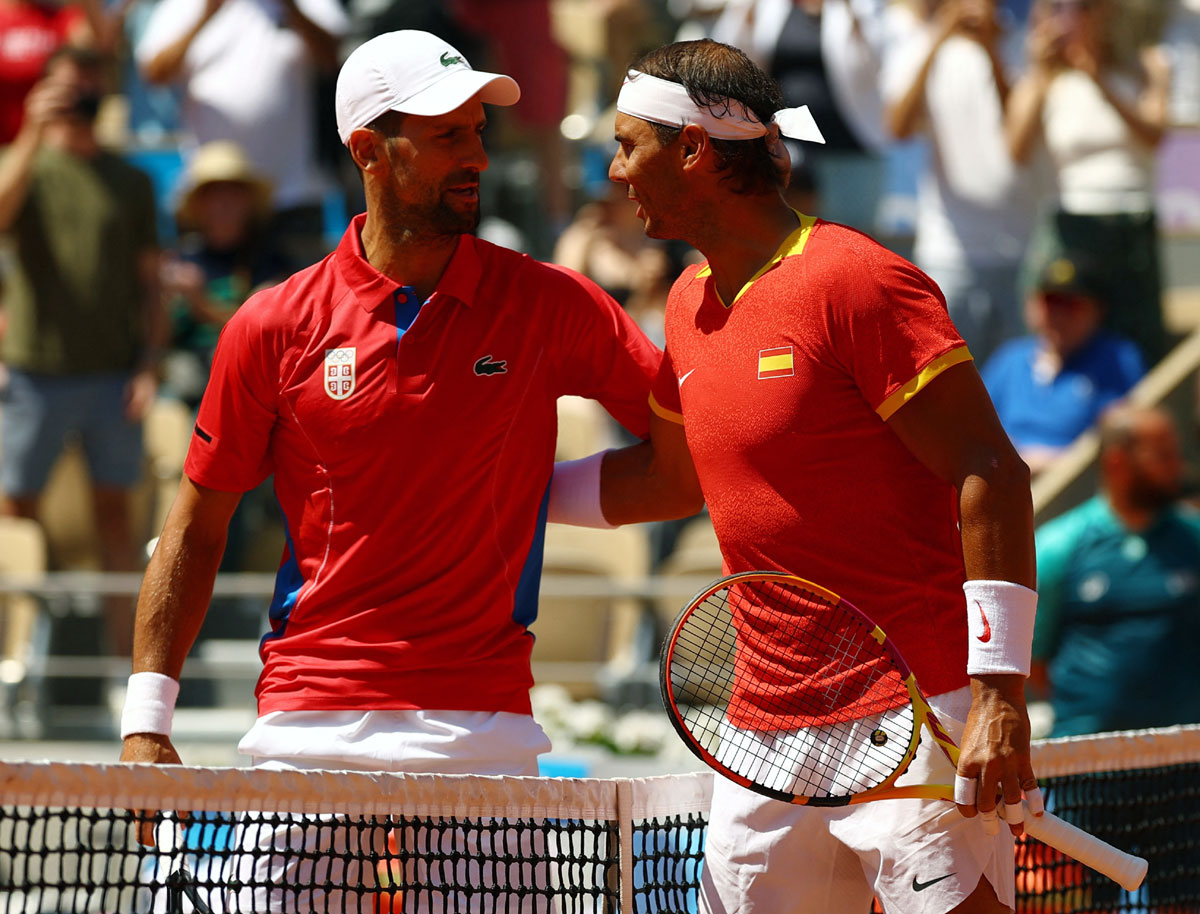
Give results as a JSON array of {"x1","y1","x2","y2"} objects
[{"x1": 654, "y1": 216, "x2": 971, "y2": 694}]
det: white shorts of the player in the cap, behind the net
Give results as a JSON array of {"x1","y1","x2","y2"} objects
[{"x1": 149, "y1": 710, "x2": 550, "y2": 914}]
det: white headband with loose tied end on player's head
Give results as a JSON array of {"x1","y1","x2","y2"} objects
[{"x1": 617, "y1": 70, "x2": 824, "y2": 143}]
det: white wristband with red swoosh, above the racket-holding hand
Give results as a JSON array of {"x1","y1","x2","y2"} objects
[{"x1": 962, "y1": 581, "x2": 1038, "y2": 677}]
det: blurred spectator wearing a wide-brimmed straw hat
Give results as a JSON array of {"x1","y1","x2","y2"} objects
[{"x1": 162, "y1": 140, "x2": 287, "y2": 407}]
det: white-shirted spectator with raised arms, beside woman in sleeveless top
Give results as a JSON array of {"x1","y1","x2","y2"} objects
[{"x1": 883, "y1": 0, "x2": 1036, "y2": 365}]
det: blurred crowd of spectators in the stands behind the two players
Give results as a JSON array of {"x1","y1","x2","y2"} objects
[{"x1": 0, "y1": 0, "x2": 1200, "y2": 738}]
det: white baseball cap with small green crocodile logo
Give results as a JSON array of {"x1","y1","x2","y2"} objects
[{"x1": 335, "y1": 29, "x2": 521, "y2": 143}]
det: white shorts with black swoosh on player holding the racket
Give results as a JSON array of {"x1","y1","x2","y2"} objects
[{"x1": 701, "y1": 688, "x2": 1015, "y2": 914}]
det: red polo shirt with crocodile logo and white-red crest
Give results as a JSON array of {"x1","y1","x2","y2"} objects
[{"x1": 185, "y1": 216, "x2": 661, "y2": 714}]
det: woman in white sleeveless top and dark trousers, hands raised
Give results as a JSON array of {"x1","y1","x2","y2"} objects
[{"x1": 1007, "y1": 0, "x2": 1170, "y2": 365}]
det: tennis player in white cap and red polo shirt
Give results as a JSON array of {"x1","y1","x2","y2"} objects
[{"x1": 121, "y1": 31, "x2": 698, "y2": 912}]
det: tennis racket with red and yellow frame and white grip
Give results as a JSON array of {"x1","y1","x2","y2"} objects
[{"x1": 659, "y1": 571, "x2": 1147, "y2": 891}]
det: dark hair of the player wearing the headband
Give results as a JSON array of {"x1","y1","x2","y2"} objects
[{"x1": 630, "y1": 38, "x2": 784, "y2": 193}]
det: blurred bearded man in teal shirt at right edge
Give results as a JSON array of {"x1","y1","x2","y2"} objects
[{"x1": 1030, "y1": 405, "x2": 1200, "y2": 736}]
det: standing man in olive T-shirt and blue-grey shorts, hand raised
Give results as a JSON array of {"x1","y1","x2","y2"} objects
[{"x1": 0, "y1": 46, "x2": 166, "y2": 656}]
